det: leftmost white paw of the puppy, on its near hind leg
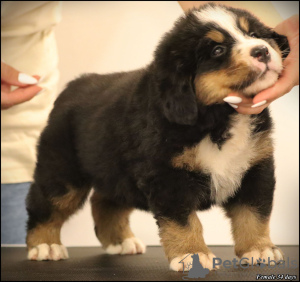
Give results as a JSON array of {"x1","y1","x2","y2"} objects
[{"x1": 27, "y1": 243, "x2": 69, "y2": 261}]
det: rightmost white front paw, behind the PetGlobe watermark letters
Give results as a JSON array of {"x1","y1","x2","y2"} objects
[{"x1": 241, "y1": 247, "x2": 283, "y2": 265}]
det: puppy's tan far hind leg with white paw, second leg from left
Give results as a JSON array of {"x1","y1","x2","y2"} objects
[{"x1": 91, "y1": 191, "x2": 146, "y2": 255}]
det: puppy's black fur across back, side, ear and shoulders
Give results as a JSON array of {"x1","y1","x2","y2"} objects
[{"x1": 27, "y1": 3, "x2": 288, "y2": 229}]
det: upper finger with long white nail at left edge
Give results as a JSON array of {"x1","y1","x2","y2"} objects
[{"x1": 1, "y1": 62, "x2": 38, "y2": 87}]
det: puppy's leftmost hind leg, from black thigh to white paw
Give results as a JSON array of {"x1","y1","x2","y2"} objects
[{"x1": 26, "y1": 107, "x2": 91, "y2": 260}]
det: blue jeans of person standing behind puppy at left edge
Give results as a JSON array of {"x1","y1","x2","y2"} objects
[{"x1": 1, "y1": 182, "x2": 31, "y2": 244}]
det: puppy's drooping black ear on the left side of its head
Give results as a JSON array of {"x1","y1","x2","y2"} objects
[{"x1": 154, "y1": 12, "x2": 201, "y2": 125}]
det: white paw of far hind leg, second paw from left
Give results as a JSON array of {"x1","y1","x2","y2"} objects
[{"x1": 106, "y1": 237, "x2": 146, "y2": 255}]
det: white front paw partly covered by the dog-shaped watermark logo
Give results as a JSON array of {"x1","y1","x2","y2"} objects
[{"x1": 170, "y1": 253, "x2": 219, "y2": 271}]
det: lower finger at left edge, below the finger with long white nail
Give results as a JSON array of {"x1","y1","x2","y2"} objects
[{"x1": 1, "y1": 85, "x2": 42, "y2": 110}]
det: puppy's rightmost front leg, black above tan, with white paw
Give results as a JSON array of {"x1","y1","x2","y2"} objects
[{"x1": 224, "y1": 157, "x2": 283, "y2": 264}]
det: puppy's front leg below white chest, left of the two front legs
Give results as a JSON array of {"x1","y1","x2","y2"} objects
[{"x1": 148, "y1": 168, "x2": 214, "y2": 271}]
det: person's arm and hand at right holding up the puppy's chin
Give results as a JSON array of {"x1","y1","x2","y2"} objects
[{"x1": 179, "y1": 1, "x2": 299, "y2": 114}]
